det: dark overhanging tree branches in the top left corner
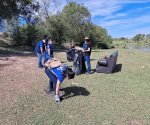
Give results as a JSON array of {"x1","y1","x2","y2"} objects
[{"x1": 0, "y1": 0, "x2": 39, "y2": 23}]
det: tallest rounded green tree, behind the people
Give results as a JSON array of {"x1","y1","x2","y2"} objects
[{"x1": 62, "y1": 2, "x2": 91, "y2": 43}]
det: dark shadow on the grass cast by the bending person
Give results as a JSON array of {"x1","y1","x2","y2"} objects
[{"x1": 61, "y1": 86, "x2": 90, "y2": 99}]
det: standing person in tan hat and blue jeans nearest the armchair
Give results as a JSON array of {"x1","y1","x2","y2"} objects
[{"x1": 83, "y1": 36, "x2": 91, "y2": 74}]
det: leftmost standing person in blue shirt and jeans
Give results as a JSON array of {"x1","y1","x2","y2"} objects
[{"x1": 34, "y1": 35, "x2": 47, "y2": 68}]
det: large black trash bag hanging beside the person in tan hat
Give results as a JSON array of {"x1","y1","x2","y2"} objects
[{"x1": 73, "y1": 51, "x2": 86, "y2": 75}]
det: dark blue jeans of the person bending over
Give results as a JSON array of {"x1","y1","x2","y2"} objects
[{"x1": 45, "y1": 68, "x2": 57, "y2": 94}]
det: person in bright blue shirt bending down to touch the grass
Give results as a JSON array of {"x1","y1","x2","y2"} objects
[{"x1": 45, "y1": 58, "x2": 75, "y2": 103}]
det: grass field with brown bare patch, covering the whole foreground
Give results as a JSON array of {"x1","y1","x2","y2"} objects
[{"x1": 0, "y1": 48, "x2": 150, "y2": 125}]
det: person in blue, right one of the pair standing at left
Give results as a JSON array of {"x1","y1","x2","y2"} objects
[{"x1": 44, "y1": 39, "x2": 54, "y2": 63}]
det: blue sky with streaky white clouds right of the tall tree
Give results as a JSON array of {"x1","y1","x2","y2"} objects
[{"x1": 56, "y1": 0, "x2": 150, "y2": 38}]
